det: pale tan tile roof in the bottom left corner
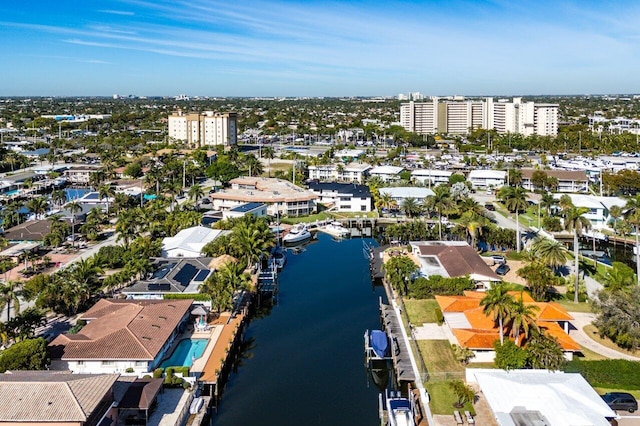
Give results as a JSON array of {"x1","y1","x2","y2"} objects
[{"x1": 0, "y1": 371, "x2": 119, "y2": 422}]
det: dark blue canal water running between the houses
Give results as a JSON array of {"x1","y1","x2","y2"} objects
[{"x1": 212, "y1": 233, "x2": 384, "y2": 426}]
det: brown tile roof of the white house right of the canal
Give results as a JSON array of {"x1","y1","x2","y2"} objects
[{"x1": 417, "y1": 244, "x2": 501, "y2": 281}]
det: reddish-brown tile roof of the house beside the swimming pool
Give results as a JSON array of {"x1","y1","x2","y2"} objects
[{"x1": 49, "y1": 299, "x2": 192, "y2": 360}]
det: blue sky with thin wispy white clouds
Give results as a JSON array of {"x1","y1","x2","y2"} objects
[{"x1": 0, "y1": 0, "x2": 640, "y2": 96}]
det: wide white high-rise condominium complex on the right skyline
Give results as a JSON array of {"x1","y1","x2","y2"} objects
[{"x1": 400, "y1": 97, "x2": 558, "y2": 136}]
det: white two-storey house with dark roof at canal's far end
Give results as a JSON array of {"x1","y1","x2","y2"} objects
[{"x1": 309, "y1": 182, "x2": 373, "y2": 212}]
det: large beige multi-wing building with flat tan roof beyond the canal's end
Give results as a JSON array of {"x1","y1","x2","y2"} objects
[{"x1": 209, "y1": 177, "x2": 318, "y2": 217}]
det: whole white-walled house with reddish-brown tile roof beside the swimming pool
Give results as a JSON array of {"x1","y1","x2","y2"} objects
[{"x1": 49, "y1": 299, "x2": 193, "y2": 374}]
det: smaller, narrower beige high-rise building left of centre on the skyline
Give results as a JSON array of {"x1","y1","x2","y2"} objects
[{"x1": 169, "y1": 111, "x2": 238, "y2": 147}]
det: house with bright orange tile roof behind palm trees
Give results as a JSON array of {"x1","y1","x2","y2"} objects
[{"x1": 436, "y1": 291, "x2": 581, "y2": 362}]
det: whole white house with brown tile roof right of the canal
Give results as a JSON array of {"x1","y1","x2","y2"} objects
[{"x1": 409, "y1": 241, "x2": 502, "y2": 289}]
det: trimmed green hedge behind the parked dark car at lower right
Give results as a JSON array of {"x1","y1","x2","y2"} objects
[{"x1": 564, "y1": 359, "x2": 640, "y2": 390}]
